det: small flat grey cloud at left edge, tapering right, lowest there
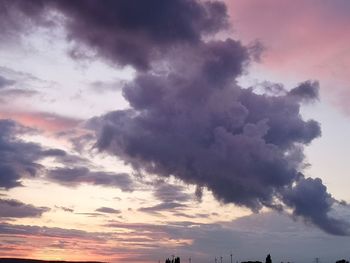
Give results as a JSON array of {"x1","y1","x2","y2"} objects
[{"x1": 0, "y1": 199, "x2": 50, "y2": 218}]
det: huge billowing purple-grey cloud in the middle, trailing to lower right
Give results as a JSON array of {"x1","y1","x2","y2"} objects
[{"x1": 91, "y1": 35, "x2": 348, "y2": 235}]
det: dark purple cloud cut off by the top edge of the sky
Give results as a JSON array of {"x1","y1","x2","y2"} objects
[{"x1": 0, "y1": 0, "x2": 227, "y2": 69}]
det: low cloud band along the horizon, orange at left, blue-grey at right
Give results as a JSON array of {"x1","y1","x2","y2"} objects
[{"x1": 0, "y1": 209, "x2": 349, "y2": 262}]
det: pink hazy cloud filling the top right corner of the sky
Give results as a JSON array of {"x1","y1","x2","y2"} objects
[{"x1": 226, "y1": 0, "x2": 350, "y2": 113}]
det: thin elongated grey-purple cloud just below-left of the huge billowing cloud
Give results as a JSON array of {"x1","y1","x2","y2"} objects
[{"x1": 47, "y1": 167, "x2": 133, "y2": 191}]
